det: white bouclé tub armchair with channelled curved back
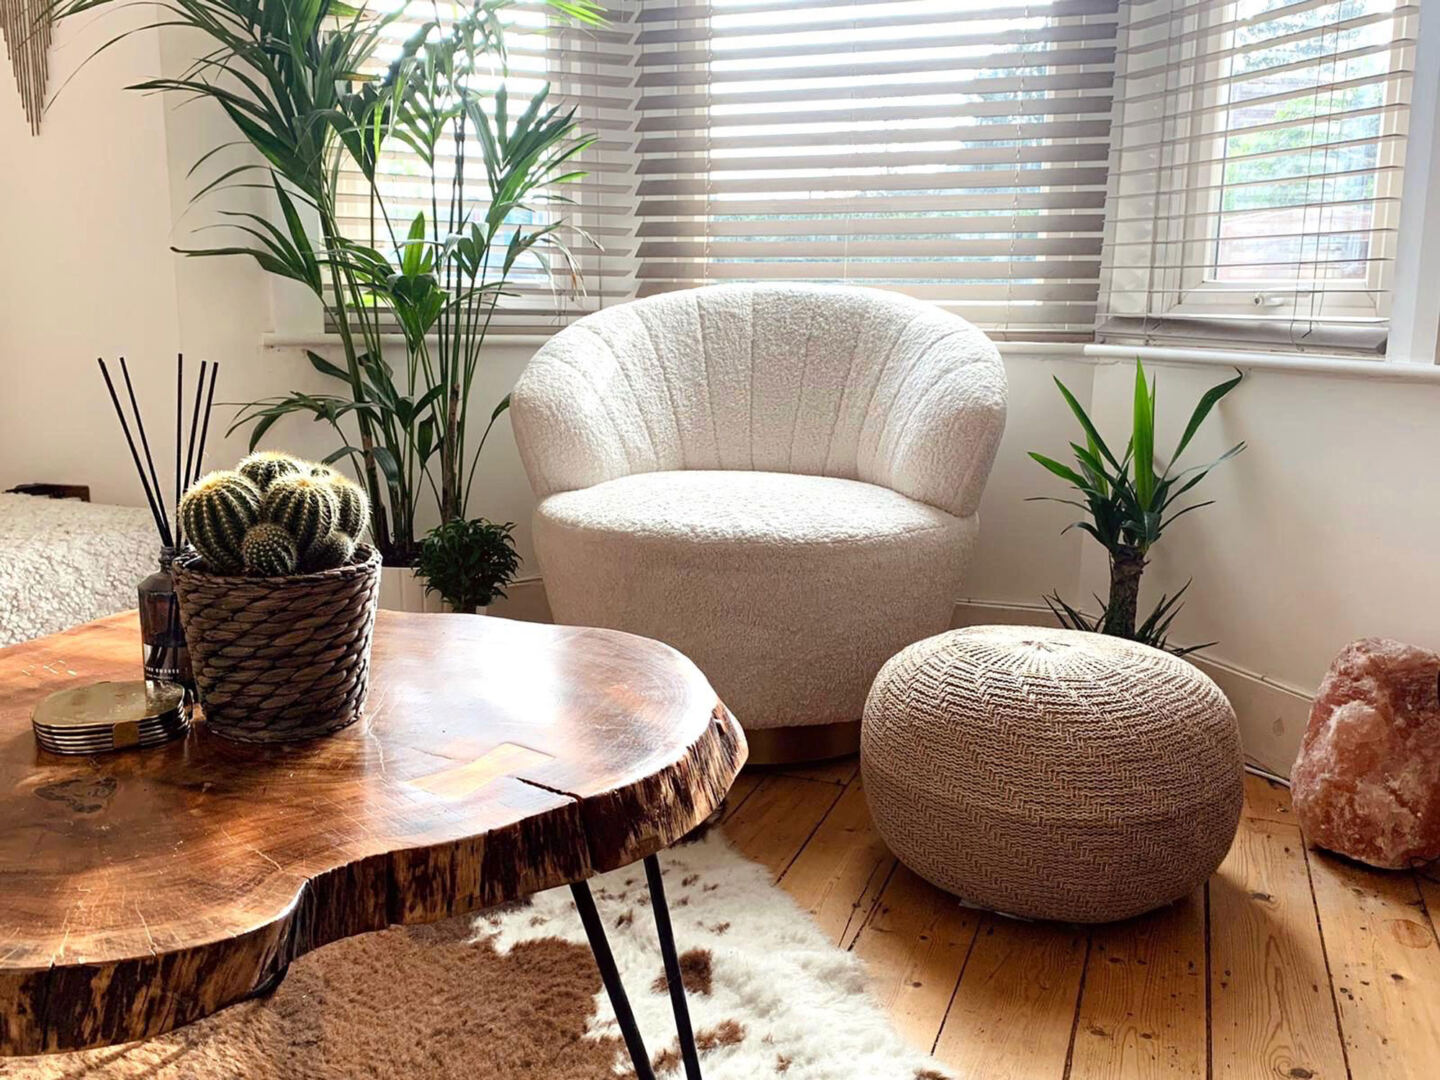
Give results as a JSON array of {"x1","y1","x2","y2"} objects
[{"x1": 511, "y1": 285, "x2": 1005, "y2": 762}]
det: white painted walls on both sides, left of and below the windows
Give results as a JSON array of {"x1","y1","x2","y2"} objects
[{"x1": 0, "y1": 22, "x2": 1440, "y2": 760}]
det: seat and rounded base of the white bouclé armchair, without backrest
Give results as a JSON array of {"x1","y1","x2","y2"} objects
[{"x1": 534, "y1": 469, "x2": 976, "y2": 729}]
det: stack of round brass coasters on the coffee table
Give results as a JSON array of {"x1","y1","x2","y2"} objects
[{"x1": 30, "y1": 680, "x2": 190, "y2": 753}]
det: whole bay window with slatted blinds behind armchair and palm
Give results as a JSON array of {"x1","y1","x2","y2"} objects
[{"x1": 324, "y1": 0, "x2": 1418, "y2": 354}]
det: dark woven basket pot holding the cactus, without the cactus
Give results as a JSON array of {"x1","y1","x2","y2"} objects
[{"x1": 174, "y1": 546, "x2": 380, "y2": 743}]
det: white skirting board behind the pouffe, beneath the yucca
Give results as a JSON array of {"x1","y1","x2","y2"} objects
[{"x1": 950, "y1": 600, "x2": 1313, "y2": 778}]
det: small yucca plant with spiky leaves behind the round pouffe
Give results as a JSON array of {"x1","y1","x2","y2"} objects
[{"x1": 1030, "y1": 360, "x2": 1246, "y2": 654}]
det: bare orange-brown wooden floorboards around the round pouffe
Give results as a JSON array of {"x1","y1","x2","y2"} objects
[{"x1": 724, "y1": 759, "x2": 1440, "y2": 1080}]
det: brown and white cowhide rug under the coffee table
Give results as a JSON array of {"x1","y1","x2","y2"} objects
[{"x1": 0, "y1": 831, "x2": 945, "y2": 1080}]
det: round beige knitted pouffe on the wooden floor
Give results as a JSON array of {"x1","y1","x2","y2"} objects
[{"x1": 860, "y1": 626, "x2": 1244, "y2": 923}]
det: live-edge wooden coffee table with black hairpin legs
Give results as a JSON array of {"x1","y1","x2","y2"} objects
[{"x1": 0, "y1": 612, "x2": 746, "y2": 1080}]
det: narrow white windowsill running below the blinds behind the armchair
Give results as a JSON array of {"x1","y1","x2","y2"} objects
[{"x1": 261, "y1": 333, "x2": 1440, "y2": 383}]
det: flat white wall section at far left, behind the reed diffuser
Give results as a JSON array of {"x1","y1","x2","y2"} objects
[{"x1": 0, "y1": 12, "x2": 179, "y2": 501}]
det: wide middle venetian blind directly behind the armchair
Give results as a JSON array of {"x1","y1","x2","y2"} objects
[{"x1": 636, "y1": 0, "x2": 1119, "y2": 340}]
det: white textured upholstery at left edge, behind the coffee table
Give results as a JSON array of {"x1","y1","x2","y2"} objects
[{"x1": 0, "y1": 494, "x2": 160, "y2": 648}]
